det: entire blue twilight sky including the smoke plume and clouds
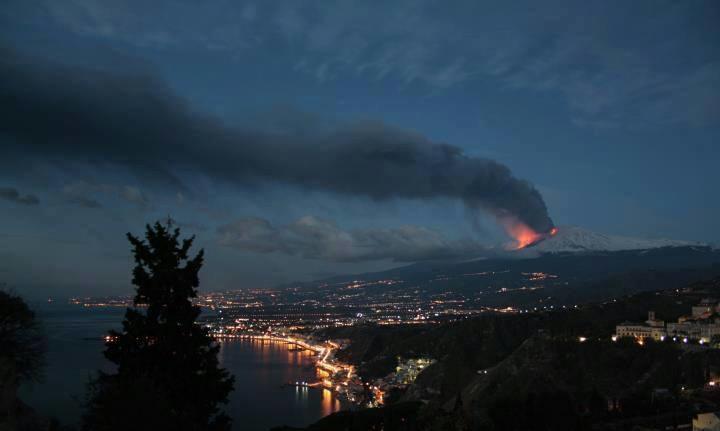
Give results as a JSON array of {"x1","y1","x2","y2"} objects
[{"x1": 0, "y1": 0, "x2": 720, "y2": 297}]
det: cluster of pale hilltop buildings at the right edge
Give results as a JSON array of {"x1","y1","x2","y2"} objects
[{"x1": 615, "y1": 299, "x2": 720, "y2": 343}]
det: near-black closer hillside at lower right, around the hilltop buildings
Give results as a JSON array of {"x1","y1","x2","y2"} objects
[{"x1": 288, "y1": 278, "x2": 720, "y2": 430}]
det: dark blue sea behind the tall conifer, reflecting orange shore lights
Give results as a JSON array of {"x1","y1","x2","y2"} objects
[{"x1": 19, "y1": 303, "x2": 342, "y2": 431}]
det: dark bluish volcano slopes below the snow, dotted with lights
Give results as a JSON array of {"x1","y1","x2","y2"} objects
[{"x1": 290, "y1": 246, "x2": 720, "y2": 308}]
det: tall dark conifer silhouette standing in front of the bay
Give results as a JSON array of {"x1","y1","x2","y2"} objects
[{"x1": 83, "y1": 220, "x2": 234, "y2": 431}]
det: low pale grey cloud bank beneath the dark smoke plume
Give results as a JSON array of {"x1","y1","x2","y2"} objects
[{"x1": 217, "y1": 216, "x2": 488, "y2": 262}]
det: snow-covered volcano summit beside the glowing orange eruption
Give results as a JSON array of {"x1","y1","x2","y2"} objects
[{"x1": 529, "y1": 226, "x2": 704, "y2": 253}]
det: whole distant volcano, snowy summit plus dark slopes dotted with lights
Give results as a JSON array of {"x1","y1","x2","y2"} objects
[{"x1": 281, "y1": 226, "x2": 720, "y2": 307}]
